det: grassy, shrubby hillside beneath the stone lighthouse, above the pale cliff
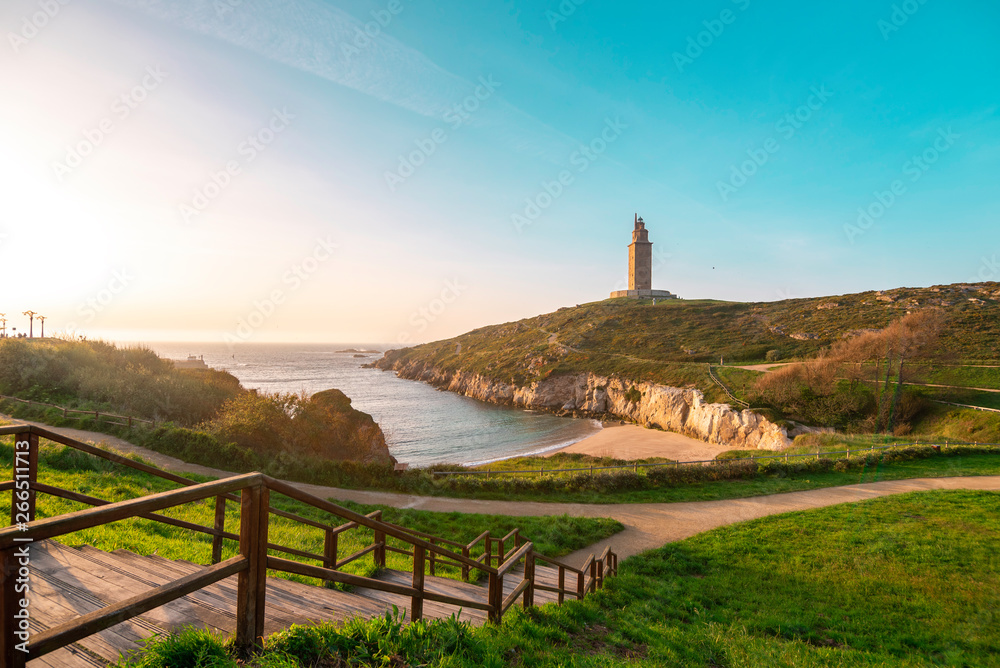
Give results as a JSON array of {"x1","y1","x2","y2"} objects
[{"x1": 378, "y1": 283, "x2": 1000, "y2": 440}]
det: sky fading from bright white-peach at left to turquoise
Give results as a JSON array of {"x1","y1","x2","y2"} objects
[{"x1": 0, "y1": 0, "x2": 1000, "y2": 342}]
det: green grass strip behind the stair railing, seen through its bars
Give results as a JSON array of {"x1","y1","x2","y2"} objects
[{"x1": 0, "y1": 437, "x2": 622, "y2": 582}]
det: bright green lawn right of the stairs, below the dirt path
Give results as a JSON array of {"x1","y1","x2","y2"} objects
[{"x1": 119, "y1": 491, "x2": 1000, "y2": 668}]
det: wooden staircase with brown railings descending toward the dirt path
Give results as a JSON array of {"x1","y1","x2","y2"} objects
[{"x1": 0, "y1": 425, "x2": 618, "y2": 668}]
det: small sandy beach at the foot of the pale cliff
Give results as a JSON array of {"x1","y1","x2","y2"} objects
[{"x1": 548, "y1": 422, "x2": 733, "y2": 462}]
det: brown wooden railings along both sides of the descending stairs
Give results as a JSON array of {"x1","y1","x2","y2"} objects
[{"x1": 0, "y1": 425, "x2": 618, "y2": 668}]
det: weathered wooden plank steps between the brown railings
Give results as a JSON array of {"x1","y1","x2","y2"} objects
[{"x1": 28, "y1": 540, "x2": 558, "y2": 668}]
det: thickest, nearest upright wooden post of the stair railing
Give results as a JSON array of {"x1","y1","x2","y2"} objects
[{"x1": 236, "y1": 481, "x2": 268, "y2": 657}]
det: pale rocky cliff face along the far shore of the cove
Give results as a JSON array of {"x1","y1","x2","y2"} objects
[{"x1": 374, "y1": 358, "x2": 791, "y2": 450}]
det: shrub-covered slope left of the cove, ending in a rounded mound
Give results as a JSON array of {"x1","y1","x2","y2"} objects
[{"x1": 0, "y1": 339, "x2": 392, "y2": 470}]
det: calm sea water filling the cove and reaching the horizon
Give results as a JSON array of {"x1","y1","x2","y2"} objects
[{"x1": 146, "y1": 343, "x2": 601, "y2": 466}]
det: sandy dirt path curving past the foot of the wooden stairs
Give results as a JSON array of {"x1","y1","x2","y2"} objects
[{"x1": 8, "y1": 418, "x2": 1000, "y2": 565}]
